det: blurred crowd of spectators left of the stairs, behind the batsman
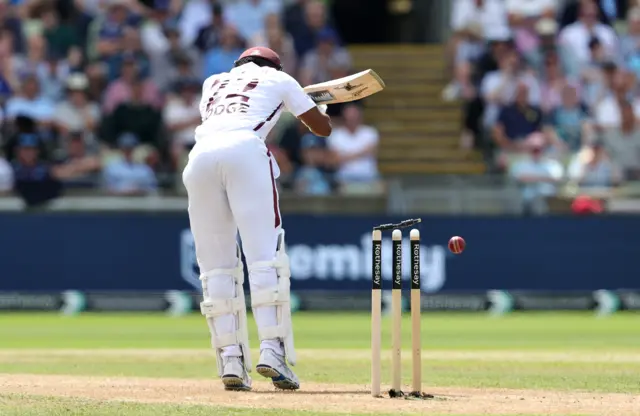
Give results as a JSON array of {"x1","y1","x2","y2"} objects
[{"x1": 0, "y1": 0, "x2": 378, "y2": 205}]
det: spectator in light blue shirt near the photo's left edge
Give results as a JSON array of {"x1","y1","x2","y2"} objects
[{"x1": 6, "y1": 75, "x2": 54, "y2": 127}]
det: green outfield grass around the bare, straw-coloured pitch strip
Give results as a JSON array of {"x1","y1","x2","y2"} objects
[{"x1": 0, "y1": 313, "x2": 640, "y2": 416}]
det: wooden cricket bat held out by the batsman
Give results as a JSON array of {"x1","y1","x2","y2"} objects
[{"x1": 304, "y1": 69, "x2": 385, "y2": 105}]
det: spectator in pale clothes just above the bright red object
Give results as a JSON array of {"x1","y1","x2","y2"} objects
[{"x1": 569, "y1": 141, "x2": 622, "y2": 188}]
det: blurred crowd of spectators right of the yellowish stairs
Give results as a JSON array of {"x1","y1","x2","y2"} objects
[{"x1": 443, "y1": 0, "x2": 640, "y2": 212}]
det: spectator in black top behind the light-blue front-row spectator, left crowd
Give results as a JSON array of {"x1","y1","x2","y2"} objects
[{"x1": 103, "y1": 75, "x2": 162, "y2": 154}]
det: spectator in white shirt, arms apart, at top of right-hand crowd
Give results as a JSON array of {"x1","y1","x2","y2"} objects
[{"x1": 558, "y1": 2, "x2": 618, "y2": 70}]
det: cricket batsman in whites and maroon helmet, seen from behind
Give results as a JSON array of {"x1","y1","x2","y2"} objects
[{"x1": 182, "y1": 47, "x2": 332, "y2": 391}]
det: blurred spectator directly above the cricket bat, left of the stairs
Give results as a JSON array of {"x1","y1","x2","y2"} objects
[{"x1": 300, "y1": 28, "x2": 351, "y2": 85}]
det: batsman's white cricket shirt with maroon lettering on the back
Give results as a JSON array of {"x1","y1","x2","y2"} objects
[{"x1": 196, "y1": 63, "x2": 316, "y2": 141}]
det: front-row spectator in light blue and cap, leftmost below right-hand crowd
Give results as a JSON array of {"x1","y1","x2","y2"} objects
[{"x1": 509, "y1": 135, "x2": 563, "y2": 214}]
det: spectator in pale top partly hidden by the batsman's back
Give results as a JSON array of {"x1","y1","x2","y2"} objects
[{"x1": 162, "y1": 78, "x2": 202, "y2": 171}]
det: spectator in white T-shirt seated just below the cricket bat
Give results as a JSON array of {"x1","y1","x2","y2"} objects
[{"x1": 328, "y1": 104, "x2": 379, "y2": 184}]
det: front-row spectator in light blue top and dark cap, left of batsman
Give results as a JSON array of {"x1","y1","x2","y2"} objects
[{"x1": 104, "y1": 133, "x2": 158, "y2": 196}]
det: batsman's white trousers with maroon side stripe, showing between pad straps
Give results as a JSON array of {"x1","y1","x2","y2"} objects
[{"x1": 182, "y1": 133, "x2": 284, "y2": 357}]
